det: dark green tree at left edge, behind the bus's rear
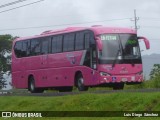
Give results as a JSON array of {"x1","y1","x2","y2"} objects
[{"x1": 0, "y1": 34, "x2": 16, "y2": 89}]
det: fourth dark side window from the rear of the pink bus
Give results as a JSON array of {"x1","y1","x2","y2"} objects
[{"x1": 41, "y1": 38, "x2": 50, "y2": 54}]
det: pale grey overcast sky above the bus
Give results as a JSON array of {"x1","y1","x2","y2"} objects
[{"x1": 0, "y1": 0, "x2": 160, "y2": 54}]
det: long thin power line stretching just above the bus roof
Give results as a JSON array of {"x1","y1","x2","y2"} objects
[{"x1": 0, "y1": 18, "x2": 130, "y2": 31}]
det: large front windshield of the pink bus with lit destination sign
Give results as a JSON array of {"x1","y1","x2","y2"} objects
[{"x1": 100, "y1": 34, "x2": 141, "y2": 63}]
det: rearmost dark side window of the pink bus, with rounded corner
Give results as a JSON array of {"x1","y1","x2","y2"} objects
[{"x1": 14, "y1": 42, "x2": 22, "y2": 58}]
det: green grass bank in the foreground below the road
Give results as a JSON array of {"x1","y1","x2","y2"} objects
[{"x1": 0, "y1": 92, "x2": 160, "y2": 111}]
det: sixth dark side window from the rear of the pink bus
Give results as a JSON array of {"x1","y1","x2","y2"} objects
[{"x1": 63, "y1": 33, "x2": 75, "y2": 52}]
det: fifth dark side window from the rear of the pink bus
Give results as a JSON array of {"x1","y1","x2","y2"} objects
[{"x1": 52, "y1": 35, "x2": 63, "y2": 53}]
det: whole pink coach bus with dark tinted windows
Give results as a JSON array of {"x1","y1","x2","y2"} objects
[{"x1": 12, "y1": 26, "x2": 150, "y2": 93}]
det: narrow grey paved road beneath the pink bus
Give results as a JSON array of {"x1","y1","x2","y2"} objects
[{"x1": 0, "y1": 88, "x2": 160, "y2": 96}]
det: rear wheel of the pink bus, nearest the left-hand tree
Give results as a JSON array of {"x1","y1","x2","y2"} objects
[{"x1": 28, "y1": 77, "x2": 44, "y2": 93}]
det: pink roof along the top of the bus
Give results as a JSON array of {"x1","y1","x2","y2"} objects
[{"x1": 16, "y1": 25, "x2": 137, "y2": 41}]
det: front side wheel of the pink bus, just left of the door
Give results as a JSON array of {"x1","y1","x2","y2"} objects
[{"x1": 76, "y1": 73, "x2": 88, "y2": 91}]
